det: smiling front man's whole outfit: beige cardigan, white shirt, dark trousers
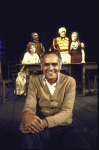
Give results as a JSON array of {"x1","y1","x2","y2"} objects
[{"x1": 22, "y1": 73, "x2": 90, "y2": 149}]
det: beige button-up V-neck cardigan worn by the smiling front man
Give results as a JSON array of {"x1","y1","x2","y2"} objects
[{"x1": 21, "y1": 73, "x2": 76, "y2": 128}]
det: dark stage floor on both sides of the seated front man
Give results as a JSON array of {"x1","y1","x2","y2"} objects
[{"x1": 0, "y1": 90, "x2": 98, "y2": 149}]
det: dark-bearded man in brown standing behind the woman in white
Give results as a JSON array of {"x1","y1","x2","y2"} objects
[{"x1": 32, "y1": 32, "x2": 45, "y2": 56}]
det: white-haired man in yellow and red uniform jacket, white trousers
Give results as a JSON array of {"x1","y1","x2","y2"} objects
[{"x1": 49, "y1": 27, "x2": 71, "y2": 63}]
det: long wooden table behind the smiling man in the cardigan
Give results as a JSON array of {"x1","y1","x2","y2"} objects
[{"x1": 16, "y1": 62, "x2": 98, "y2": 96}]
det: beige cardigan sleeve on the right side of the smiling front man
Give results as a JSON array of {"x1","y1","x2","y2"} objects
[{"x1": 46, "y1": 78, "x2": 76, "y2": 128}]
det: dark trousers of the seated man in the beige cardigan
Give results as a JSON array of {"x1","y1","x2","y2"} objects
[{"x1": 21, "y1": 124, "x2": 92, "y2": 149}]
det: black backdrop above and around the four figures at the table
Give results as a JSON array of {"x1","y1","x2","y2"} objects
[{"x1": 0, "y1": 1, "x2": 98, "y2": 78}]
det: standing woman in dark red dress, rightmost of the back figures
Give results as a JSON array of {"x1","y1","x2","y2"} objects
[{"x1": 70, "y1": 32, "x2": 85, "y2": 63}]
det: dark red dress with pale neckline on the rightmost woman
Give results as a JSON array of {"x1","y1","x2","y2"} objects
[{"x1": 70, "y1": 41, "x2": 82, "y2": 63}]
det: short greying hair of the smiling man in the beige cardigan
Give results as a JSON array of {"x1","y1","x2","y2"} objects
[{"x1": 40, "y1": 51, "x2": 62, "y2": 68}]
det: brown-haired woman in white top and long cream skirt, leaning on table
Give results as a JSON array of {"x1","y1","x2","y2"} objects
[{"x1": 16, "y1": 42, "x2": 40, "y2": 95}]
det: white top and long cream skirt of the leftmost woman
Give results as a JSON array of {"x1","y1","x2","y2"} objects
[{"x1": 16, "y1": 52, "x2": 39, "y2": 95}]
